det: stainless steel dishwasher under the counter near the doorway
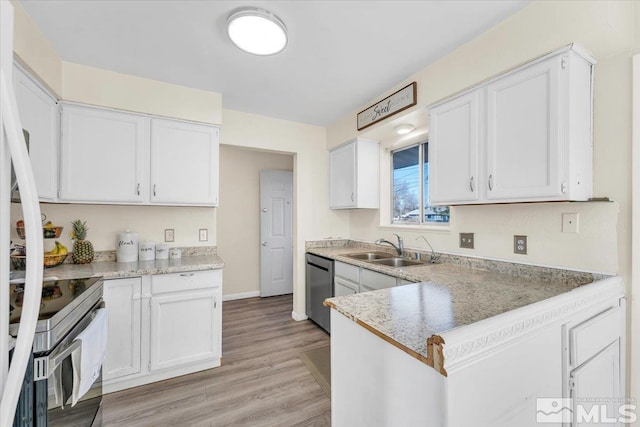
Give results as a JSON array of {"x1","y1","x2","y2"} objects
[{"x1": 306, "y1": 253, "x2": 333, "y2": 333}]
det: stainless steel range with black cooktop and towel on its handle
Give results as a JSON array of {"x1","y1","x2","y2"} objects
[{"x1": 9, "y1": 277, "x2": 103, "y2": 427}]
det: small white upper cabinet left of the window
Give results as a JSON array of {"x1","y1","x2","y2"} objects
[{"x1": 329, "y1": 139, "x2": 380, "y2": 209}]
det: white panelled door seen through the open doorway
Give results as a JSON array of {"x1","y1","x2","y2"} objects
[{"x1": 260, "y1": 170, "x2": 293, "y2": 297}]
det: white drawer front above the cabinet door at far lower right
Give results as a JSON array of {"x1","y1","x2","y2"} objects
[{"x1": 569, "y1": 307, "x2": 622, "y2": 367}]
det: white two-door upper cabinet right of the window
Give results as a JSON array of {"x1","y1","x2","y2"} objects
[{"x1": 429, "y1": 45, "x2": 595, "y2": 204}]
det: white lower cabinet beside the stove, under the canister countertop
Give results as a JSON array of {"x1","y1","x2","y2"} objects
[{"x1": 103, "y1": 270, "x2": 222, "y2": 393}]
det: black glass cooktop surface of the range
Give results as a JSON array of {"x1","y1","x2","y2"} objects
[{"x1": 9, "y1": 277, "x2": 101, "y2": 324}]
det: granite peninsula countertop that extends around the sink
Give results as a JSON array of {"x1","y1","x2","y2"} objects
[{"x1": 318, "y1": 246, "x2": 598, "y2": 374}]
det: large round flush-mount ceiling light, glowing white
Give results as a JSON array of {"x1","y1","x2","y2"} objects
[{"x1": 227, "y1": 7, "x2": 287, "y2": 55}]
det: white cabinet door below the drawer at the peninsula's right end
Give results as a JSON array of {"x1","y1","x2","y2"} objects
[{"x1": 570, "y1": 340, "x2": 623, "y2": 427}]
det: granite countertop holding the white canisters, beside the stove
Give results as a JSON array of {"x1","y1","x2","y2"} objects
[{"x1": 36, "y1": 254, "x2": 224, "y2": 279}]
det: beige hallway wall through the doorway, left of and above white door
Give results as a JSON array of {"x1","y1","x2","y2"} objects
[{"x1": 218, "y1": 145, "x2": 293, "y2": 296}]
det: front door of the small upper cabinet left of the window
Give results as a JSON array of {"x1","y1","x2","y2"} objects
[{"x1": 329, "y1": 143, "x2": 357, "y2": 209}]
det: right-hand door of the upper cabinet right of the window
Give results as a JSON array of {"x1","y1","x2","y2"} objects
[{"x1": 483, "y1": 56, "x2": 562, "y2": 200}]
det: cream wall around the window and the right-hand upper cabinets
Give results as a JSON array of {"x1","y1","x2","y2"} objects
[{"x1": 327, "y1": 1, "x2": 640, "y2": 404}]
